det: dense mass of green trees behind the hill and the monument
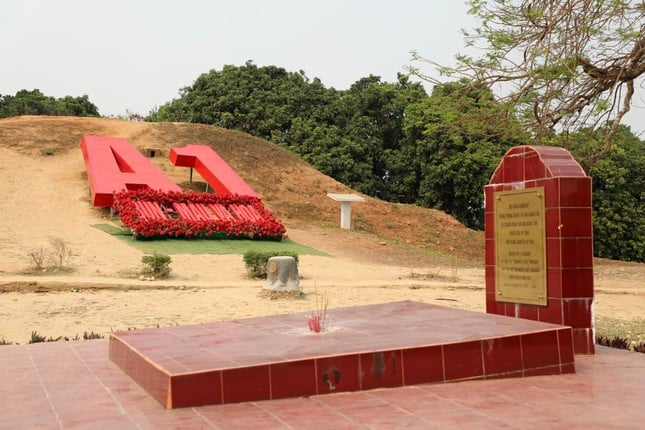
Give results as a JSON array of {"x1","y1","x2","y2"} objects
[{"x1": 148, "y1": 62, "x2": 644, "y2": 260}]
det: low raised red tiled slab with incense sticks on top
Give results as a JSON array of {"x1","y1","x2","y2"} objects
[{"x1": 109, "y1": 301, "x2": 575, "y2": 408}]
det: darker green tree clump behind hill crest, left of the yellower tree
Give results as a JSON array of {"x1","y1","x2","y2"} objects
[{"x1": 148, "y1": 62, "x2": 427, "y2": 199}]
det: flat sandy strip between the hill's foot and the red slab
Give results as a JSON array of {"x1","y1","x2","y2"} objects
[{"x1": 0, "y1": 256, "x2": 645, "y2": 343}]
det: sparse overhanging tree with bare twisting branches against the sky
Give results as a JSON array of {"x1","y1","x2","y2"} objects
[{"x1": 413, "y1": 0, "x2": 645, "y2": 161}]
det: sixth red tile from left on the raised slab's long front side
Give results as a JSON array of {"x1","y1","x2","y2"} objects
[{"x1": 402, "y1": 346, "x2": 445, "y2": 385}]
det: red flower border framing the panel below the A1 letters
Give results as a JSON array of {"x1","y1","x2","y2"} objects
[{"x1": 113, "y1": 189, "x2": 286, "y2": 240}]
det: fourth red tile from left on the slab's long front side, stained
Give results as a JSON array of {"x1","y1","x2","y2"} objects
[{"x1": 316, "y1": 355, "x2": 361, "y2": 394}]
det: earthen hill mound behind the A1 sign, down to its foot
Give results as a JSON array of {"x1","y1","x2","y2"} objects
[{"x1": 0, "y1": 116, "x2": 483, "y2": 266}]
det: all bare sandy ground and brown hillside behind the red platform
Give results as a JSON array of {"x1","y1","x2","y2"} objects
[{"x1": 0, "y1": 117, "x2": 645, "y2": 343}]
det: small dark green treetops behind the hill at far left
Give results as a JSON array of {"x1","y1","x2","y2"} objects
[{"x1": 0, "y1": 89, "x2": 100, "y2": 118}]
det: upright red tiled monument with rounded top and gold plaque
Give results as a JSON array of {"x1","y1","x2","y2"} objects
[{"x1": 484, "y1": 146, "x2": 594, "y2": 354}]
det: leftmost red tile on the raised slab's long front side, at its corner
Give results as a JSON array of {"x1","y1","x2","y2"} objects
[{"x1": 168, "y1": 371, "x2": 222, "y2": 408}]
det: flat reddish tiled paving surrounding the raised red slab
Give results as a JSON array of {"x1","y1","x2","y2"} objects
[{"x1": 0, "y1": 340, "x2": 645, "y2": 430}]
